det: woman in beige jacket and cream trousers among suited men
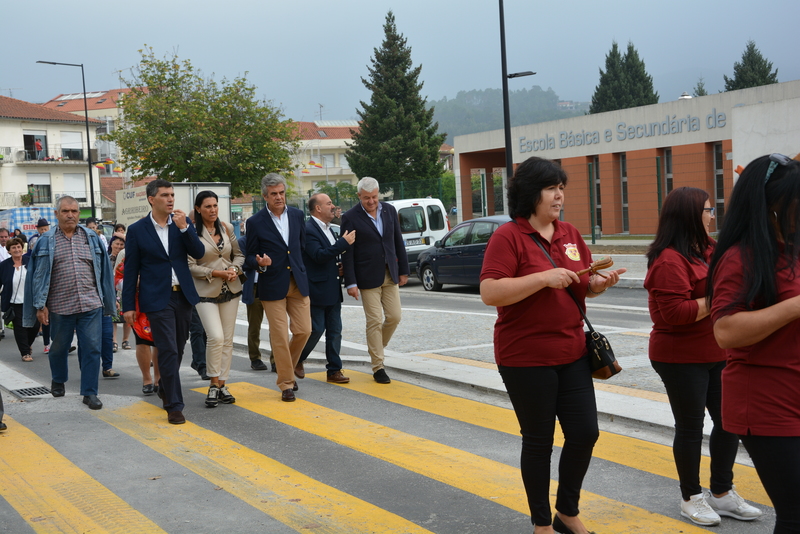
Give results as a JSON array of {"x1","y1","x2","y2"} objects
[{"x1": 189, "y1": 191, "x2": 244, "y2": 408}]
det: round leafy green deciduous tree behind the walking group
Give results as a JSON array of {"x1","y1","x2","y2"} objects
[{"x1": 105, "y1": 48, "x2": 298, "y2": 196}]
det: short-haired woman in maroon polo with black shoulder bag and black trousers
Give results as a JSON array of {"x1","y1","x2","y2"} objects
[{"x1": 481, "y1": 157, "x2": 625, "y2": 534}]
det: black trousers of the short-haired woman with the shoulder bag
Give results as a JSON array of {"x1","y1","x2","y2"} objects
[{"x1": 499, "y1": 356, "x2": 599, "y2": 526}]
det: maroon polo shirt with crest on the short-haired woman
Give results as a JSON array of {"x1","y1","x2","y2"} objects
[{"x1": 481, "y1": 217, "x2": 592, "y2": 367}]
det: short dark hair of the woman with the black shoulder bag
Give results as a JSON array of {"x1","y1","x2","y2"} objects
[{"x1": 506, "y1": 156, "x2": 567, "y2": 219}]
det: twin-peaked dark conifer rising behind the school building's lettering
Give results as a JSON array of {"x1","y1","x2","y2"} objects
[{"x1": 589, "y1": 41, "x2": 658, "y2": 113}]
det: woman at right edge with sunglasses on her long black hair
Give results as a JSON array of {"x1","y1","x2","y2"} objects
[{"x1": 708, "y1": 154, "x2": 800, "y2": 533}]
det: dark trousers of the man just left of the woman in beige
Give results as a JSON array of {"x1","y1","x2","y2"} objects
[{"x1": 147, "y1": 291, "x2": 192, "y2": 412}]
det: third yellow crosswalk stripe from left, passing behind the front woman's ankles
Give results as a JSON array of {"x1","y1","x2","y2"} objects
[{"x1": 223, "y1": 383, "x2": 705, "y2": 534}]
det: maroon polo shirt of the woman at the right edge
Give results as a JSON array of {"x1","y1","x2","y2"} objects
[{"x1": 711, "y1": 247, "x2": 800, "y2": 436}]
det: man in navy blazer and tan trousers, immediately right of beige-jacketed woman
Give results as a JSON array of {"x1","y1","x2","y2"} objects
[{"x1": 245, "y1": 173, "x2": 311, "y2": 402}]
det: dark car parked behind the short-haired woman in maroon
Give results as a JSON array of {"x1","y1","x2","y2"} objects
[{"x1": 417, "y1": 215, "x2": 511, "y2": 291}]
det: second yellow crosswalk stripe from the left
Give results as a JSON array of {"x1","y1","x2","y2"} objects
[{"x1": 96, "y1": 404, "x2": 438, "y2": 534}]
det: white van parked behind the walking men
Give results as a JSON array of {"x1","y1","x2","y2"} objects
[{"x1": 389, "y1": 198, "x2": 450, "y2": 271}]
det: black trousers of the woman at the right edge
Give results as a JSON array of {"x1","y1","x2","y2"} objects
[{"x1": 739, "y1": 436, "x2": 800, "y2": 534}]
